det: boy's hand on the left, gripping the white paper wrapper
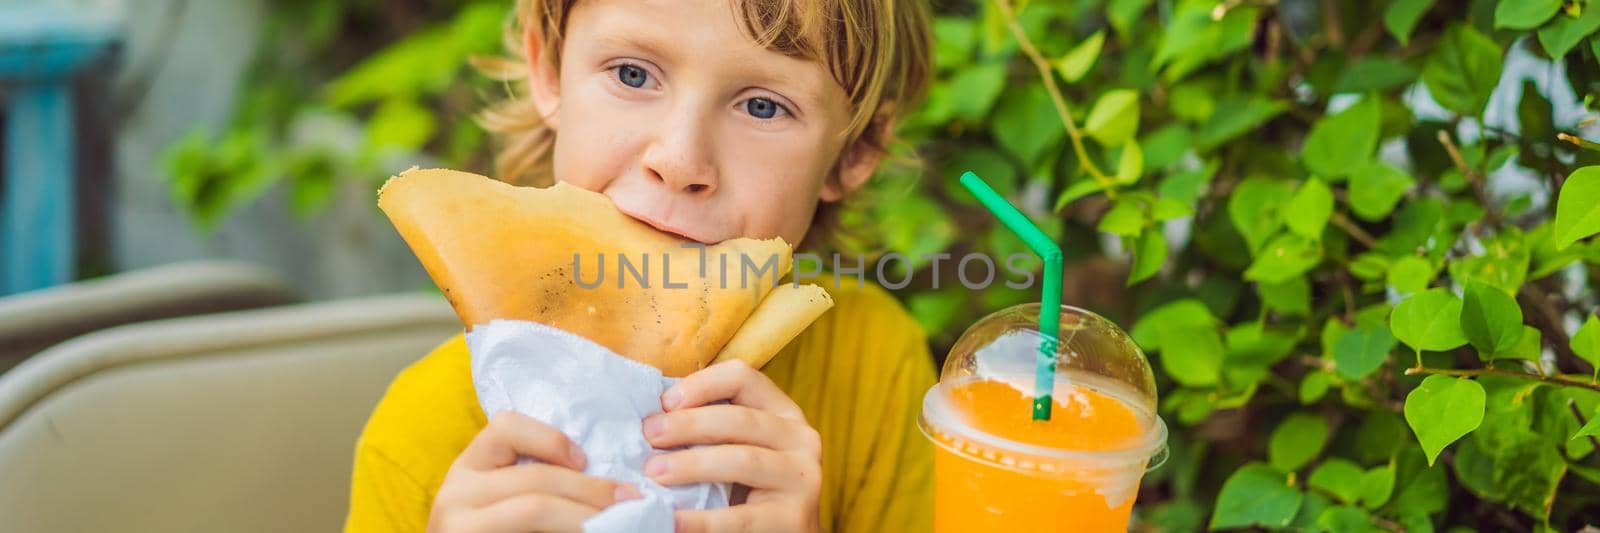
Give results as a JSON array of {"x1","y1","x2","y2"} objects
[{"x1": 427, "y1": 411, "x2": 638, "y2": 533}]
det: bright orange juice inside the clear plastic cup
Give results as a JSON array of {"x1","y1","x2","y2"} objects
[{"x1": 922, "y1": 375, "x2": 1165, "y2": 531}]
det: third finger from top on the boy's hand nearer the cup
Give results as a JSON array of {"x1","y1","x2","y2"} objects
[{"x1": 645, "y1": 445, "x2": 822, "y2": 491}]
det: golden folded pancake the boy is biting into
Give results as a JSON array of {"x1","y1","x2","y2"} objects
[{"x1": 378, "y1": 168, "x2": 832, "y2": 376}]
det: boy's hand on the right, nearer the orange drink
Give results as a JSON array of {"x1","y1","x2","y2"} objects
[{"x1": 643, "y1": 360, "x2": 822, "y2": 531}]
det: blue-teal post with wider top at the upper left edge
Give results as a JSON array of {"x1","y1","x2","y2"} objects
[{"x1": 0, "y1": 2, "x2": 118, "y2": 295}]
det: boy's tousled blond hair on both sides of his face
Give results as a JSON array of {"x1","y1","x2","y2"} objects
[{"x1": 474, "y1": 0, "x2": 933, "y2": 251}]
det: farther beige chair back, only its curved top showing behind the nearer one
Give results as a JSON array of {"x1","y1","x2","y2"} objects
[{"x1": 0, "y1": 261, "x2": 296, "y2": 373}]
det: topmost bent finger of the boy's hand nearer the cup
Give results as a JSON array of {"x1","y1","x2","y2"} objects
[{"x1": 661, "y1": 360, "x2": 805, "y2": 423}]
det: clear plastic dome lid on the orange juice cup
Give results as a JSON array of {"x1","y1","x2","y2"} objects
[{"x1": 920, "y1": 304, "x2": 1166, "y2": 480}]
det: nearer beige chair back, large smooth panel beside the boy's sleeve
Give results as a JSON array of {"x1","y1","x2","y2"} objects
[{"x1": 0, "y1": 295, "x2": 461, "y2": 533}]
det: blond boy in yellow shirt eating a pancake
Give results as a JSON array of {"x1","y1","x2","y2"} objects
[{"x1": 346, "y1": 0, "x2": 934, "y2": 531}]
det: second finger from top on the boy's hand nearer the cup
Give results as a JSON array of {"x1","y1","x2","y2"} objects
[{"x1": 642, "y1": 405, "x2": 821, "y2": 451}]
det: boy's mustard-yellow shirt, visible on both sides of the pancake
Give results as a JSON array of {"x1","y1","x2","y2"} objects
[{"x1": 346, "y1": 277, "x2": 934, "y2": 531}]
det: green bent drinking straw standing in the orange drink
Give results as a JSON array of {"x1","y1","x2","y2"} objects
[{"x1": 962, "y1": 171, "x2": 1061, "y2": 419}]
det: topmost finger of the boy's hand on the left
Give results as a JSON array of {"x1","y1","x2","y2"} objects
[{"x1": 456, "y1": 411, "x2": 586, "y2": 471}]
